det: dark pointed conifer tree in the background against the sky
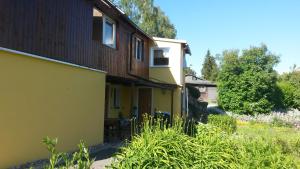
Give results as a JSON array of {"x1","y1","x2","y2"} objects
[{"x1": 201, "y1": 50, "x2": 219, "y2": 81}]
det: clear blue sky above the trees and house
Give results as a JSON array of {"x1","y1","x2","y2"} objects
[{"x1": 155, "y1": 0, "x2": 300, "y2": 74}]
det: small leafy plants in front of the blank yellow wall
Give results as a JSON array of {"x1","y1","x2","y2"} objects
[{"x1": 43, "y1": 137, "x2": 93, "y2": 169}]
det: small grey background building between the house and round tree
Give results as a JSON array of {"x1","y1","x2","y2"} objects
[{"x1": 185, "y1": 75, "x2": 218, "y2": 103}]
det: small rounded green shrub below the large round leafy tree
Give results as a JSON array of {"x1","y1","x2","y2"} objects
[{"x1": 208, "y1": 115, "x2": 236, "y2": 133}]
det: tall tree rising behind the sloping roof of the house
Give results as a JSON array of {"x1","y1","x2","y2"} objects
[{"x1": 113, "y1": 0, "x2": 177, "y2": 38}]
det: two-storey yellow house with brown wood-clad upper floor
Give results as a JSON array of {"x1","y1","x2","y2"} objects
[{"x1": 0, "y1": 0, "x2": 190, "y2": 168}]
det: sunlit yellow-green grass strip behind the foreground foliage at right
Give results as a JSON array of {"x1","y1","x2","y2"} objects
[{"x1": 237, "y1": 121, "x2": 300, "y2": 168}]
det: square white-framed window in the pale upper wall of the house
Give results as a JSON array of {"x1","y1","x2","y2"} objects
[{"x1": 153, "y1": 48, "x2": 169, "y2": 66}]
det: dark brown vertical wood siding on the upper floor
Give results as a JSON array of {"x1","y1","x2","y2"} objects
[{"x1": 0, "y1": 0, "x2": 151, "y2": 78}]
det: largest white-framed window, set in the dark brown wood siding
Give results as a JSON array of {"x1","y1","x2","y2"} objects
[{"x1": 102, "y1": 16, "x2": 116, "y2": 48}]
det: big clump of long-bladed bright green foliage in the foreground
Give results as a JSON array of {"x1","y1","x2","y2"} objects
[{"x1": 110, "y1": 117, "x2": 296, "y2": 169}]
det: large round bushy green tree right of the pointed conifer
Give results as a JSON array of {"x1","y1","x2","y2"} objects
[{"x1": 218, "y1": 45, "x2": 279, "y2": 114}]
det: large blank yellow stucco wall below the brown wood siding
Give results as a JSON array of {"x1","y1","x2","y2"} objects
[{"x1": 0, "y1": 50, "x2": 105, "y2": 168}]
